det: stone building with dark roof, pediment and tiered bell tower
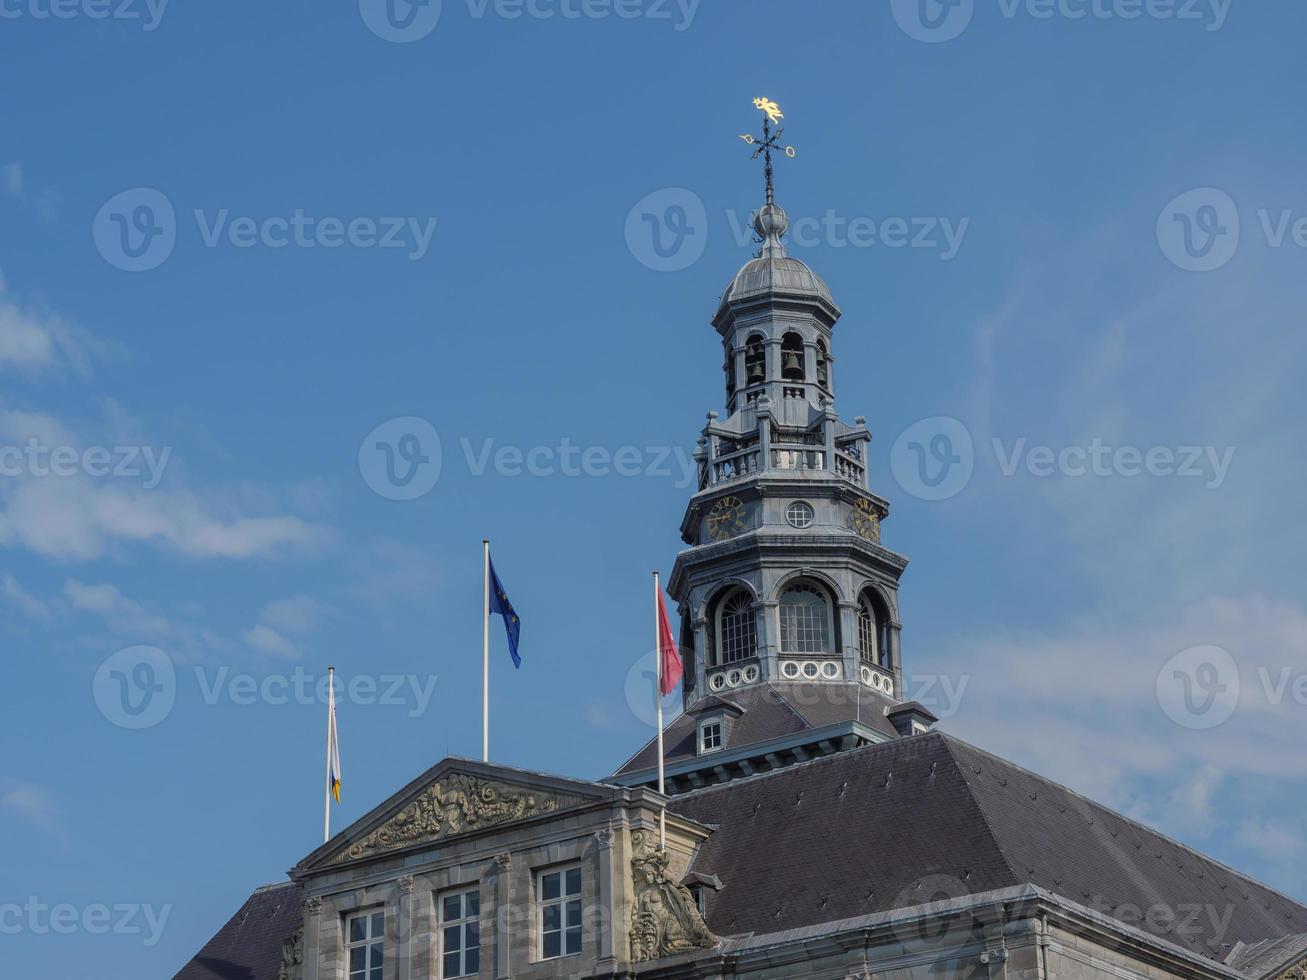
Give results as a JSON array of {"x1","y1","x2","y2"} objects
[{"x1": 178, "y1": 188, "x2": 1307, "y2": 980}]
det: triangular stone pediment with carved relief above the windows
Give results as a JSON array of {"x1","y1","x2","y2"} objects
[{"x1": 297, "y1": 760, "x2": 612, "y2": 872}]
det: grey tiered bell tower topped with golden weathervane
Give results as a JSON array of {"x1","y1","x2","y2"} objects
[{"x1": 617, "y1": 99, "x2": 936, "y2": 791}]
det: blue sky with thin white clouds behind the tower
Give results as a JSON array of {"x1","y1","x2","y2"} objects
[{"x1": 0, "y1": 0, "x2": 1307, "y2": 980}]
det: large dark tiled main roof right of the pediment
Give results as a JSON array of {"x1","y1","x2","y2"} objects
[{"x1": 672, "y1": 733, "x2": 1307, "y2": 960}]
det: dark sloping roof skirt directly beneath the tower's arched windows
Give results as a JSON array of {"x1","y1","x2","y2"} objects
[{"x1": 613, "y1": 683, "x2": 897, "y2": 776}]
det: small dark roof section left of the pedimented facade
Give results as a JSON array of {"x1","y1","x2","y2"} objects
[{"x1": 174, "y1": 882, "x2": 303, "y2": 980}]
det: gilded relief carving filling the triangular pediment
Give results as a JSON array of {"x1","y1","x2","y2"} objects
[{"x1": 333, "y1": 772, "x2": 561, "y2": 864}]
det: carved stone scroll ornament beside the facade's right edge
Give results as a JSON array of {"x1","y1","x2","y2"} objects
[{"x1": 631, "y1": 831, "x2": 718, "y2": 963}]
